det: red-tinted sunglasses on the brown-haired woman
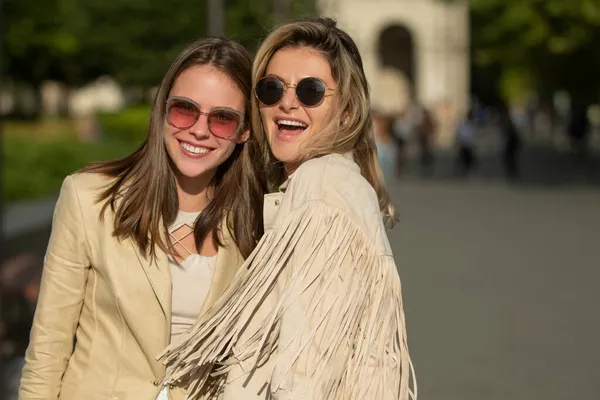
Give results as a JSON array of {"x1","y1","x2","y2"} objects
[{"x1": 166, "y1": 96, "x2": 244, "y2": 139}]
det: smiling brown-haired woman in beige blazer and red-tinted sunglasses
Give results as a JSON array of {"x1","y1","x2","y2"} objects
[{"x1": 19, "y1": 38, "x2": 264, "y2": 400}]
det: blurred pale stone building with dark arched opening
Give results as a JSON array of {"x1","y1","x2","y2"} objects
[{"x1": 320, "y1": 0, "x2": 470, "y2": 147}]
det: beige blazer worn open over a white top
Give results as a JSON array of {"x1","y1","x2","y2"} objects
[{"x1": 19, "y1": 173, "x2": 243, "y2": 400}]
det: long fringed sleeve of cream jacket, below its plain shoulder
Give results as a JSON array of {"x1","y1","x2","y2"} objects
[{"x1": 159, "y1": 200, "x2": 416, "y2": 400}]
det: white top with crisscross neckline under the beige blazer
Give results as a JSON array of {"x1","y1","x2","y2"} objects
[{"x1": 169, "y1": 210, "x2": 217, "y2": 342}]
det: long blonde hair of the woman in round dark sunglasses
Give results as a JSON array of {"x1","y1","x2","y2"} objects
[{"x1": 251, "y1": 18, "x2": 397, "y2": 227}]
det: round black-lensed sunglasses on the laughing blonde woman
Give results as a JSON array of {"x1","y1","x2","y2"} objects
[{"x1": 254, "y1": 76, "x2": 334, "y2": 107}]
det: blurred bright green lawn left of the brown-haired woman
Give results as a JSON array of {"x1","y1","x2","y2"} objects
[{"x1": 2, "y1": 136, "x2": 135, "y2": 202}]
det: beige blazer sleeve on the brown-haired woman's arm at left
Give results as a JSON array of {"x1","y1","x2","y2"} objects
[{"x1": 19, "y1": 176, "x2": 90, "y2": 400}]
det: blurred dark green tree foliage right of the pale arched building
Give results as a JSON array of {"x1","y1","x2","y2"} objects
[{"x1": 470, "y1": 0, "x2": 600, "y2": 101}]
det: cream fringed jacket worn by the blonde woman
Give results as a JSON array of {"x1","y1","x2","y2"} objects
[{"x1": 163, "y1": 155, "x2": 416, "y2": 400}]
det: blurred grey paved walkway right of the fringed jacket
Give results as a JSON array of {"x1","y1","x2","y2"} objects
[{"x1": 390, "y1": 181, "x2": 600, "y2": 400}]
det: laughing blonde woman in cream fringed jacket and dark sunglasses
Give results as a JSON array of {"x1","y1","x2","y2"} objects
[{"x1": 165, "y1": 19, "x2": 416, "y2": 400}]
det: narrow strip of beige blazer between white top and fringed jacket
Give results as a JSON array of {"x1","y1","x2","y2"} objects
[{"x1": 198, "y1": 222, "x2": 244, "y2": 316}]
